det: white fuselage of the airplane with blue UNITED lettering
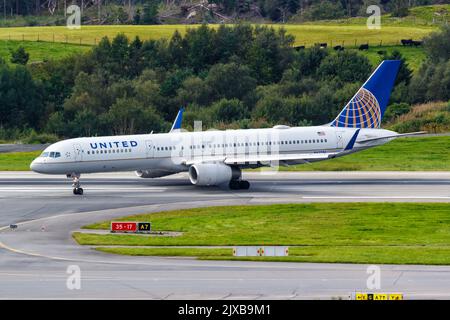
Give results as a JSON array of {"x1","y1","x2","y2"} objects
[{"x1": 30, "y1": 126, "x2": 395, "y2": 175}]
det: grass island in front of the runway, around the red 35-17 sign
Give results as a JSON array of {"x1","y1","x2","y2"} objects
[{"x1": 73, "y1": 203, "x2": 450, "y2": 264}]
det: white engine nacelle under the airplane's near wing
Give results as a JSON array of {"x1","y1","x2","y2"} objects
[{"x1": 189, "y1": 163, "x2": 241, "y2": 186}]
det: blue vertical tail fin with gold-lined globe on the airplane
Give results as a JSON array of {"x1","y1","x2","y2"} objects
[{"x1": 330, "y1": 60, "x2": 401, "y2": 128}]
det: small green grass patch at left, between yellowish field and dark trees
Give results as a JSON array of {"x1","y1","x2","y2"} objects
[{"x1": 0, "y1": 40, "x2": 91, "y2": 64}]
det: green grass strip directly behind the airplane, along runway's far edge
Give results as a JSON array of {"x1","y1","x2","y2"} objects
[{"x1": 0, "y1": 136, "x2": 450, "y2": 171}]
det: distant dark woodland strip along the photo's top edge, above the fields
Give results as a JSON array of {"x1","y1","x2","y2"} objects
[{"x1": 0, "y1": 0, "x2": 449, "y2": 26}]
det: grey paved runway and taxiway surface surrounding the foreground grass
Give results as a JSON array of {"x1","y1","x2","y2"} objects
[{"x1": 0, "y1": 172, "x2": 450, "y2": 299}]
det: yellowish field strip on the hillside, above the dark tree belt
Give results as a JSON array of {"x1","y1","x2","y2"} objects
[{"x1": 0, "y1": 24, "x2": 436, "y2": 46}]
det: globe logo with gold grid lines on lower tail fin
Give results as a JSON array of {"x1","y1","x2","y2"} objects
[{"x1": 331, "y1": 88, "x2": 381, "y2": 128}]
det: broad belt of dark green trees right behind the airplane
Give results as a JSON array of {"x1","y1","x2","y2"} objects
[{"x1": 0, "y1": 24, "x2": 450, "y2": 140}]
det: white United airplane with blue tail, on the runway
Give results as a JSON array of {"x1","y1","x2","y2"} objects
[{"x1": 30, "y1": 60, "x2": 425, "y2": 195}]
